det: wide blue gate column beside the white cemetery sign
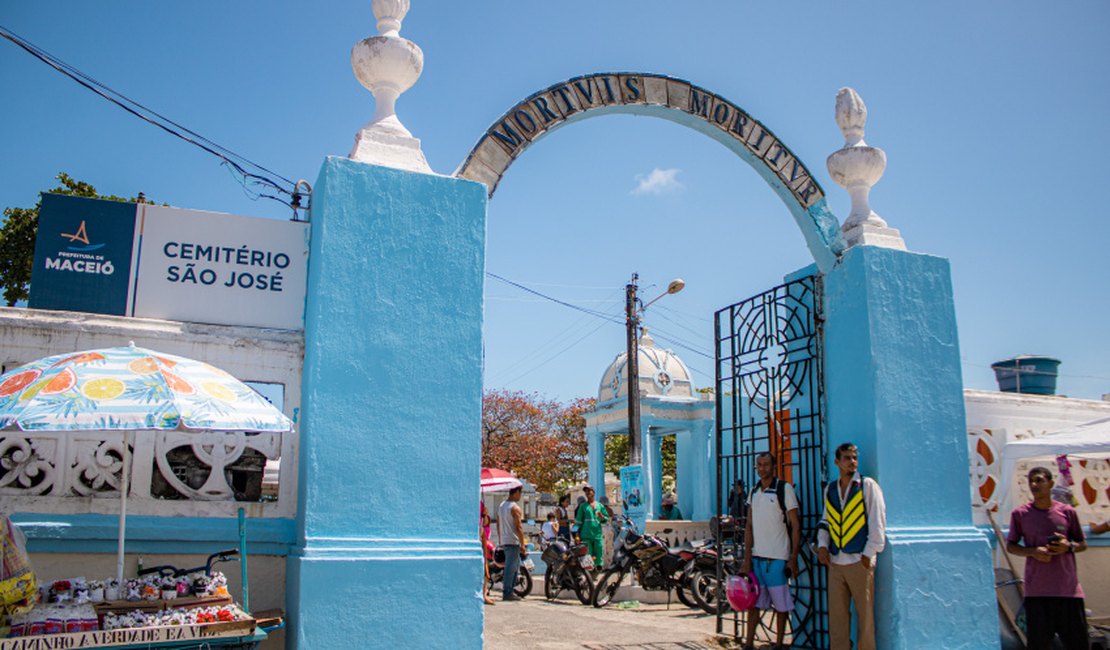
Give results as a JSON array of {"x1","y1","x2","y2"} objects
[{"x1": 287, "y1": 158, "x2": 486, "y2": 649}]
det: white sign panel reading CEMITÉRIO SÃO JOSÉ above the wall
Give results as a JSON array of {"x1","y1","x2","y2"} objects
[{"x1": 132, "y1": 205, "x2": 309, "y2": 329}]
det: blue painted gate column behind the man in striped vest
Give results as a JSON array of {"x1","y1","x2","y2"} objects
[{"x1": 825, "y1": 246, "x2": 999, "y2": 650}]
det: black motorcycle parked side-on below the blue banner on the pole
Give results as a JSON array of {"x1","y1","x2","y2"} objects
[{"x1": 591, "y1": 515, "x2": 697, "y2": 608}]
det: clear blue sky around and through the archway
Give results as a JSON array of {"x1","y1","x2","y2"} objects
[{"x1": 0, "y1": 0, "x2": 1110, "y2": 399}]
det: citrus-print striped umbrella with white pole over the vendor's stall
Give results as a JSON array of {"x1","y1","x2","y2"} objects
[{"x1": 0, "y1": 344, "x2": 293, "y2": 581}]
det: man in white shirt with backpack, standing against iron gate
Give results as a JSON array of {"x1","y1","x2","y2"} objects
[{"x1": 740, "y1": 451, "x2": 801, "y2": 650}]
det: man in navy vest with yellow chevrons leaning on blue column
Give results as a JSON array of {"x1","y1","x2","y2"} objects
[{"x1": 817, "y1": 443, "x2": 887, "y2": 650}]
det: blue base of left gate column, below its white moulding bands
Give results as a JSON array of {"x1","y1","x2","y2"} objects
[{"x1": 286, "y1": 542, "x2": 483, "y2": 650}]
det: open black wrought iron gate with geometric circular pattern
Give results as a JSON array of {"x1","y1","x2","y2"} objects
[{"x1": 715, "y1": 276, "x2": 828, "y2": 649}]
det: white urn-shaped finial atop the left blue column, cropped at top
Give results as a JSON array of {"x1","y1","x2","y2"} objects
[{"x1": 350, "y1": 0, "x2": 432, "y2": 173}]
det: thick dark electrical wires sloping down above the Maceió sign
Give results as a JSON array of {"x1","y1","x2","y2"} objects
[{"x1": 0, "y1": 26, "x2": 295, "y2": 206}]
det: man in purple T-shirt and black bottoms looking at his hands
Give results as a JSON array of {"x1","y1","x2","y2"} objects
[{"x1": 1006, "y1": 467, "x2": 1088, "y2": 650}]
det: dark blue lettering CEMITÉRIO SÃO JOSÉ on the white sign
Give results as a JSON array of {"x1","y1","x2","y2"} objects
[{"x1": 162, "y1": 242, "x2": 290, "y2": 292}]
